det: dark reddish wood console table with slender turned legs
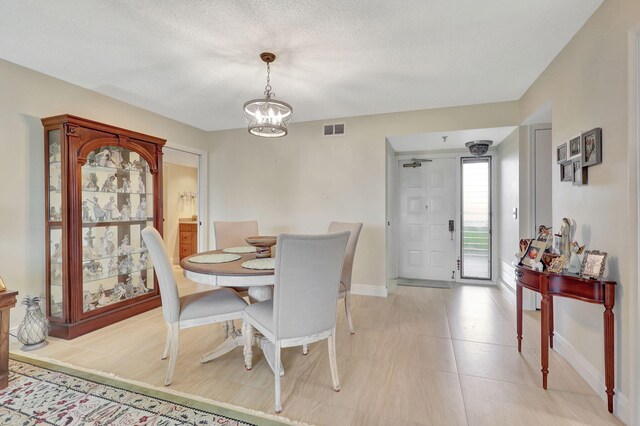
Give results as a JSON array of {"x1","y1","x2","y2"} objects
[{"x1": 515, "y1": 266, "x2": 616, "y2": 413}]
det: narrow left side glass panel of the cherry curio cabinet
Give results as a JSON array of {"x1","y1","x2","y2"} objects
[{"x1": 47, "y1": 129, "x2": 66, "y2": 318}]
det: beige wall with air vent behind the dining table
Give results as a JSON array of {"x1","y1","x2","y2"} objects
[{"x1": 209, "y1": 102, "x2": 518, "y2": 286}]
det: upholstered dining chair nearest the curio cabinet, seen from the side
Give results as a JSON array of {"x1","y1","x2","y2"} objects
[{"x1": 142, "y1": 226, "x2": 247, "y2": 386}]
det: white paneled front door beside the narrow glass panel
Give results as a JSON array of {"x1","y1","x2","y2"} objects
[{"x1": 398, "y1": 158, "x2": 457, "y2": 280}]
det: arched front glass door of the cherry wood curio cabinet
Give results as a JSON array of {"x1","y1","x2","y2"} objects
[{"x1": 80, "y1": 146, "x2": 154, "y2": 314}]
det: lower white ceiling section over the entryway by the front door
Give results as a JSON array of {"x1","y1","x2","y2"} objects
[{"x1": 387, "y1": 126, "x2": 517, "y2": 153}]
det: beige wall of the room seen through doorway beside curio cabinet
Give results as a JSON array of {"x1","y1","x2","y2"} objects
[{"x1": 163, "y1": 163, "x2": 198, "y2": 264}]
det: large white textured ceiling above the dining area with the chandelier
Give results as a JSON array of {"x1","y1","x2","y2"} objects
[{"x1": 0, "y1": 0, "x2": 602, "y2": 130}]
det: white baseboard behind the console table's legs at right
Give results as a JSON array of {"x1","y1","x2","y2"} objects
[{"x1": 553, "y1": 332, "x2": 629, "y2": 424}]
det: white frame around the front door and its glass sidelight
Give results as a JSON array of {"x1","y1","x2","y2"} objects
[{"x1": 387, "y1": 148, "x2": 498, "y2": 285}]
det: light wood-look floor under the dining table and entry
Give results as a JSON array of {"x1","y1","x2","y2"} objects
[{"x1": 12, "y1": 271, "x2": 619, "y2": 426}]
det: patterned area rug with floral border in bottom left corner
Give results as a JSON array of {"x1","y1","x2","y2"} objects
[{"x1": 0, "y1": 354, "x2": 284, "y2": 426}]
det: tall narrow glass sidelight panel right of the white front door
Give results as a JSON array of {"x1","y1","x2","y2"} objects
[{"x1": 460, "y1": 157, "x2": 491, "y2": 280}]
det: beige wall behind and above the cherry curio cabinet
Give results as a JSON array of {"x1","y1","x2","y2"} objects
[{"x1": 0, "y1": 60, "x2": 206, "y2": 327}]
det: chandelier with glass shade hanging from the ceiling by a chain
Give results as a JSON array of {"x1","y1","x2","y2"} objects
[{"x1": 243, "y1": 52, "x2": 293, "y2": 138}]
